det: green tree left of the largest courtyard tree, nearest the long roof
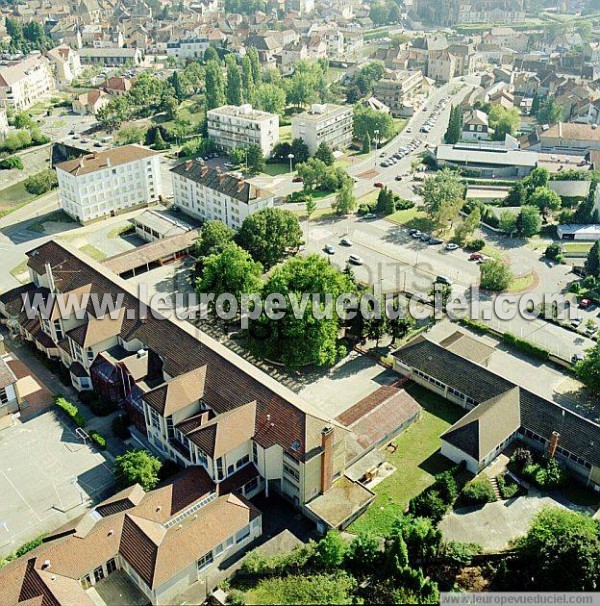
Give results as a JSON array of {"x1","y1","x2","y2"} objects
[{"x1": 196, "y1": 242, "x2": 263, "y2": 302}]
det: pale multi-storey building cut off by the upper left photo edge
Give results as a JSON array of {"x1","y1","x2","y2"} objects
[{"x1": 0, "y1": 53, "x2": 55, "y2": 112}]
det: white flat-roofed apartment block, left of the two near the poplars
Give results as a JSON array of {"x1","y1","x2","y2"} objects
[{"x1": 206, "y1": 105, "x2": 279, "y2": 156}]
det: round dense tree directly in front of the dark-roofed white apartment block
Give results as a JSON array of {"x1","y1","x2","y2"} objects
[{"x1": 236, "y1": 208, "x2": 303, "y2": 269}]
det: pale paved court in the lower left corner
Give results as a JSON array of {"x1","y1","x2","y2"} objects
[{"x1": 0, "y1": 410, "x2": 113, "y2": 555}]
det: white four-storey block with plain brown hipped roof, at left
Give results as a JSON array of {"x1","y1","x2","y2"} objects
[{"x1": 56, "y1": 145, "x2": 162, "y2": 224}]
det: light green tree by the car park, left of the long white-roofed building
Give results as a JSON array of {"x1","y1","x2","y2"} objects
[{"x1": 422, "y1": 169, "x2": 465, "y2": 228}]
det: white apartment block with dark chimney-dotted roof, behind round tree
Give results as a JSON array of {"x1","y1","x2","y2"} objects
[{"x1": 171, "y1": 160, "x2": 274, "y2": 229}]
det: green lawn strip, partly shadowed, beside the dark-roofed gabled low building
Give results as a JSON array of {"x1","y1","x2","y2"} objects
[{"x1": 349, "y1": 384, "x2": 464, "y2": 536}]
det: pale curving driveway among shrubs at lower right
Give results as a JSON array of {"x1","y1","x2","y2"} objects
[{"x1": 439, "y1": 495, "x2": 564, "y2": 551}]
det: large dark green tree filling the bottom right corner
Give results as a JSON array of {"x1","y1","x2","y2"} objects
[{"x1": 517, "y1": 507, "x2": 600, "y2": 591}]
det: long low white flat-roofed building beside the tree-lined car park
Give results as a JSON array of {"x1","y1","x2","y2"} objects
[{"x1": 436, "y1": 143, "x2": 538, "y2": 178}]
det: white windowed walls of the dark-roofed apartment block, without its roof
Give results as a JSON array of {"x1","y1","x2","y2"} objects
[{"x1": 173, "y1": 169, "x2": 274, "y2": 229}]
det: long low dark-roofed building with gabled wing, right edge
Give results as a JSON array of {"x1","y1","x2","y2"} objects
[{"x1": 394, "y1": 337, "x2": 600, "y2": 492}]
